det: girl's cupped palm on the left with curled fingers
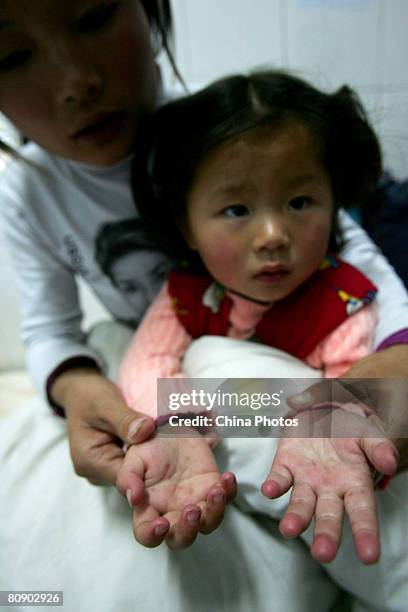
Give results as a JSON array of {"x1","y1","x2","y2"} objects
[{"x1": 117, "y1": 436, "x2": 236, "y2": 548}]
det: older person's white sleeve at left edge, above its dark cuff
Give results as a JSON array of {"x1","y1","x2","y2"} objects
[{"x1": 1, "y1": 189, "x2": 102, "y2": 395}]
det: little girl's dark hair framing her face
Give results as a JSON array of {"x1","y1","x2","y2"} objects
[{"x1": 132, "y1": 70, "x2": 381, "y2": 267}]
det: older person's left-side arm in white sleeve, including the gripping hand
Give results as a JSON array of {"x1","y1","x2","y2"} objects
[{"x1": 0, "y1": 169, "x2": 154, "y2": 484}]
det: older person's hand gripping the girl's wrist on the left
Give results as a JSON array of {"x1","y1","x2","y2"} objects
[{"x1": 51, "y1": 368, "x2": 155, "y2": 485}]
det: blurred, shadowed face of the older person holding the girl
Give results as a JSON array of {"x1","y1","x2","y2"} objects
[{"x1": 0, "y1": 0, "x2": 156, "y2": 165}]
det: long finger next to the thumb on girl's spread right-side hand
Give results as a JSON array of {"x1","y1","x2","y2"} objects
[{"x1": 344, "y1": 485, "x2": 380, "y2": 564}]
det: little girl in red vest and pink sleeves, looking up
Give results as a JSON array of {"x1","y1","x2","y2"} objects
[{"x1": 119, "y1": 71, "x2": 402, "y2": 563}]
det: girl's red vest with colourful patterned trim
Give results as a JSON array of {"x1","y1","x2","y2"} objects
[{"x1": 169, "y1": 255, "x2": 377, "y2": 359}]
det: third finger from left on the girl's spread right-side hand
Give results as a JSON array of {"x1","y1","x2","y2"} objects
[{"x1": 311, "y1": 491, "x2": 344, "y2": 563}]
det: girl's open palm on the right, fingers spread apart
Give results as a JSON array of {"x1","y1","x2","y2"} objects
[{"x1": 262, "y1": 412, "x2": 397, "y2": 564}]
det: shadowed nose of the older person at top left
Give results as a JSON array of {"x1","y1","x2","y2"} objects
[{"x1": 54, "y1": 42, "x2": 103, "y2": 105}]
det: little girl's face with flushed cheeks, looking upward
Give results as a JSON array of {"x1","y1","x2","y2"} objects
[{"x1": 183, "y1": 121, "x2": 333, "y2": 302}]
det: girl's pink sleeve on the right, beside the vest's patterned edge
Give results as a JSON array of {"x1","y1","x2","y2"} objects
[{"x1": 306, "y1": 303, "x2": 377, "y2": 378}]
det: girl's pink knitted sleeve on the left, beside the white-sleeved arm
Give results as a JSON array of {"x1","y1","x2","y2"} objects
[{"x1": 118, "y1": 283, "x2": 192, "y2": 418}]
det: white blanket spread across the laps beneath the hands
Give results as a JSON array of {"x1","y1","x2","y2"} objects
[{"x1": 0, "y1": 330, "x2": 398, "y2": 612}]
